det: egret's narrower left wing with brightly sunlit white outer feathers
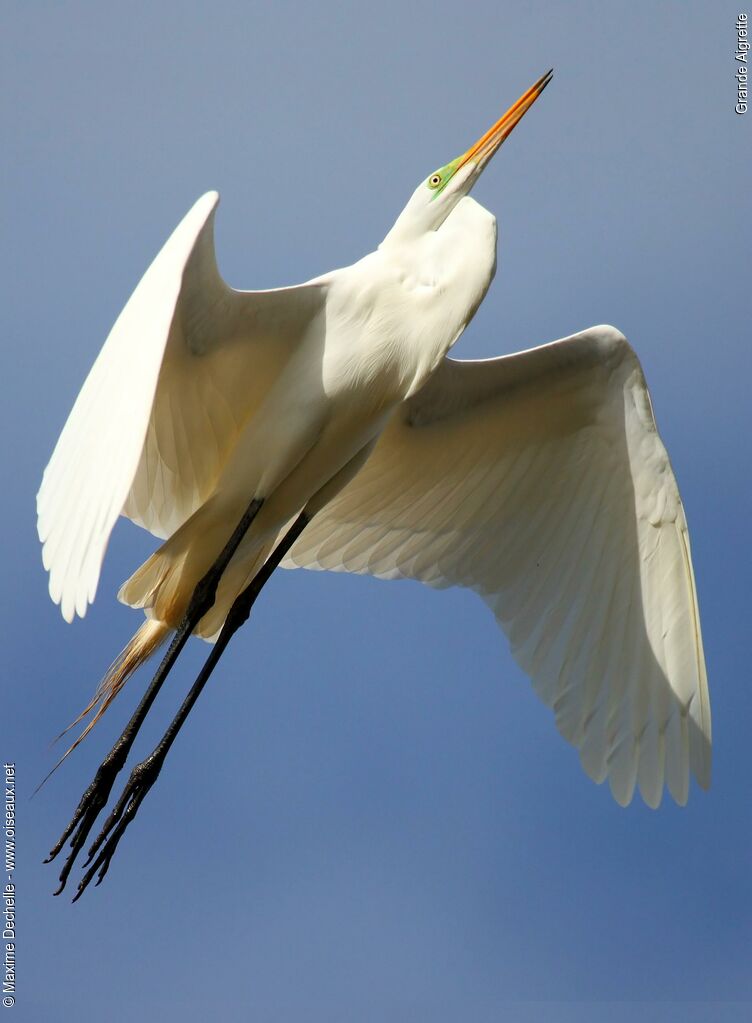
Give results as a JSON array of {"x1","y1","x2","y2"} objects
[{"x1": 37, "y1": 192, "x2": 324, "y2": 621}]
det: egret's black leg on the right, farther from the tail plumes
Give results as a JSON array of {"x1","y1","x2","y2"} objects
[{"x1": 69, "y1": 513, "x2": 310, "y2": 902}]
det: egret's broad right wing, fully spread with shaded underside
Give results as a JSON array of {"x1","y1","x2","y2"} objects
[{"x1": 287, "y1": 326, "x2": 710, "y2": 806}]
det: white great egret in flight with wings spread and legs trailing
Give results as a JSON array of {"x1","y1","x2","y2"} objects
[{"x1": 38, "y1": 72, "x2": 710, "y2": 898}]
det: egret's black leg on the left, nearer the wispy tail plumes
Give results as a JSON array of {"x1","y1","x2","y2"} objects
[{"x1": 45, "y1": 498, "x2": 264, "y2": 895}]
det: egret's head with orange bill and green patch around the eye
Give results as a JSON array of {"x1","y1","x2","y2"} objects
[{"x1": 384, "y1": 69, "x2": 554, "y2": 243}]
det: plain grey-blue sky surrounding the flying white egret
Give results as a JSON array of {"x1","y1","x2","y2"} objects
[{"x1": 0, "y1": 0, "x2": 752, "y2": 1023}]
